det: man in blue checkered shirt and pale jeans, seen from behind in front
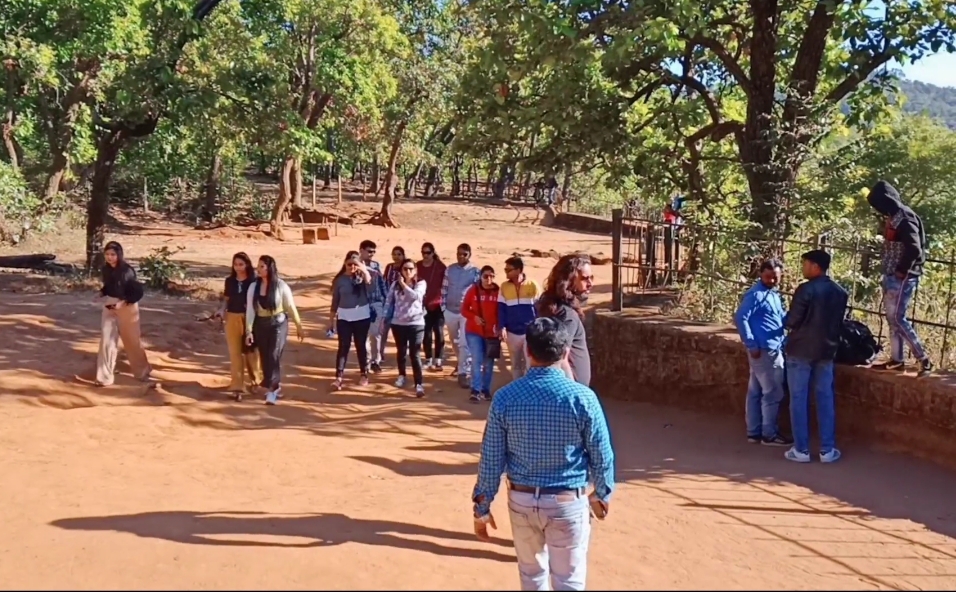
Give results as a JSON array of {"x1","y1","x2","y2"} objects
[{"x1": 472, "y1": 318, "x2": 614, "y2": 590}]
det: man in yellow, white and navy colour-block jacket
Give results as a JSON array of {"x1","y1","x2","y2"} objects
[{"x1": 498, "y1": 256, "x2": 541, "y2": 380}]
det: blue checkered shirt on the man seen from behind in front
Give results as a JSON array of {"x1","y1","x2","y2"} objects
[{"x1": 472, "y1": 367, "x2": 614, "y2": 516}]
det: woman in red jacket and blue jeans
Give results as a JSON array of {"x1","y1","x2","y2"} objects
[{"x1": 461, "y1": 265, "x2": 501, "y2": 403}]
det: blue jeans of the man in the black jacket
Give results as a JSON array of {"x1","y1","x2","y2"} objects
[{"x1": 787, "y1": 356, "x2": 836, "y2": 454}]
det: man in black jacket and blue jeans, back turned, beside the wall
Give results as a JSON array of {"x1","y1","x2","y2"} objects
[{"x1": 783, "y1": 250, "x2": 848, "y2": 463}]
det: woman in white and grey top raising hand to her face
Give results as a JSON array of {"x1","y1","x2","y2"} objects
[{"x1": 385, "y1": 259, "x2": 427, "y2": 398}]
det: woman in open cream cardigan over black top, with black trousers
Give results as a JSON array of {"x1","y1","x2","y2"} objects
[{"x1": 246, "y1": 255, "x2": 305, "y2": 405}]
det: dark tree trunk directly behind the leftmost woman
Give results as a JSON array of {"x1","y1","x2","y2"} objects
[{"x1": 86, "y1": 130, "x2": 126, "y2": 270}]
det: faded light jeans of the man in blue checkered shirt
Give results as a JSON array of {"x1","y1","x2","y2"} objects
[{"x1": 508, "y1": 491, "x2": 591, "y2": 590}]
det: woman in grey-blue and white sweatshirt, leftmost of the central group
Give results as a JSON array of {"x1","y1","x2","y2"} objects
[{"x1": 329, "y1": 251, "x2": 373, "y2": 390}]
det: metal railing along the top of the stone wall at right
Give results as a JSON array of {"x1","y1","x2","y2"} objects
[{"x1": 611, "y1": 209, "x2": 956, "y2": 368}]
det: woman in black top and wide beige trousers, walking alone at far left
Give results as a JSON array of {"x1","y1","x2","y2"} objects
[{"x1": 94, "y1": 241, "x2": 152, "y2": 386}]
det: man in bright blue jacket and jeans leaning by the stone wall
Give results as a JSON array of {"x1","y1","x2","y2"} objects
[{"x1": 734, "y1": 259, "x2": 793, "y2": 446}]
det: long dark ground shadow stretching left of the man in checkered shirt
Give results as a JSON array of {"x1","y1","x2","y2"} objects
[{"x1": 50, "y1": 511, "x2": 515, "y2": 562}]
